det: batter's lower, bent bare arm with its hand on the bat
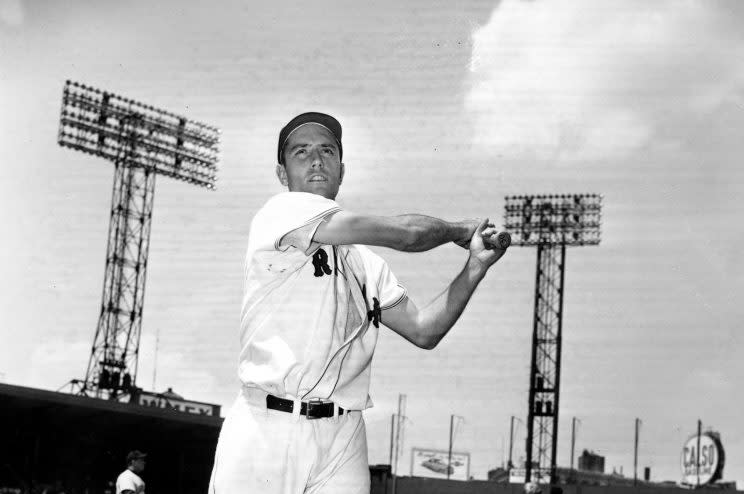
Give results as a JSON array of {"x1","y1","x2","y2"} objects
[{"x1": 381, "y1": 220, "x2": 506, "y2": 349}]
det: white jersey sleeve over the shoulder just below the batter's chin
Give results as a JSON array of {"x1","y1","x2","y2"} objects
[{"x1": 248, "y1": 192, "x2": 341, "y2": 255}]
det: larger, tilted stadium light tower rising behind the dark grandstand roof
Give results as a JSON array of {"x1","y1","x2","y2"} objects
[{"x1": 58, "y1": 80, "x2": 219, "y2": 399}]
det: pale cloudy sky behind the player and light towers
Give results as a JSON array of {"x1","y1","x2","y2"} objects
[{"x1": 0, "y1": 0, "x2": 744, "y2": 488}]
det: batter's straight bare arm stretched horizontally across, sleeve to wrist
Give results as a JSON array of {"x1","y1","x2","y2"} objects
[{"x1": 313, "y1": 211, "x2": 478, "y2": 252}]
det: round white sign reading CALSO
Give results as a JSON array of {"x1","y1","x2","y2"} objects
[{"x1": 680, "y1": 432, "x2": 724, "y2": 485}]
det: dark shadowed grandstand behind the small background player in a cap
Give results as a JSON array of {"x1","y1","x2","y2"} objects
[{"x1": 0, "y1": 384, "x2": 222, "y2": 494}]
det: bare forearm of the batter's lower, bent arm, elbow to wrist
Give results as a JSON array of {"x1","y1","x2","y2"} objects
[{"x1": 416, "y1": 258, "x2": 488, "y2": 349}]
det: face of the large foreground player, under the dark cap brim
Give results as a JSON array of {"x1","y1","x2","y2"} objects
[{"x1": 276, "y1": 124, "x2": 344, "y2": 199}]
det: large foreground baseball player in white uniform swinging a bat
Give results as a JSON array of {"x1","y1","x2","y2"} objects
[{"x1": 209, "y1": 113, "x2": 505, "y2": 494}]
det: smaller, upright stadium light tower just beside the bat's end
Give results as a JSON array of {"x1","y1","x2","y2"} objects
[{"x1": 504, "y1": 194, "x2": 602, "y2": 483}]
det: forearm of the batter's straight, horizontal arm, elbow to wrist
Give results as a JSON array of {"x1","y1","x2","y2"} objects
[{"x1": 395, "y1": 214, "x2": 472, "y2": 252}]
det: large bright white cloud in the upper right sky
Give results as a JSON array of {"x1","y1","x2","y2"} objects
[{"x1": 465, "y1": 0, "x2": 744, "y2": 161}]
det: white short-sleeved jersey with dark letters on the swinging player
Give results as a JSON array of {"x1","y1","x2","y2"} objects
[{"x1": 238, "y1": 192, "x2": 406, "y2": 410}]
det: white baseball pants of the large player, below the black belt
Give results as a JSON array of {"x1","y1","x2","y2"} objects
[{"x1": 209, "y1": 388, "x2": 370, "y2": 494}]
